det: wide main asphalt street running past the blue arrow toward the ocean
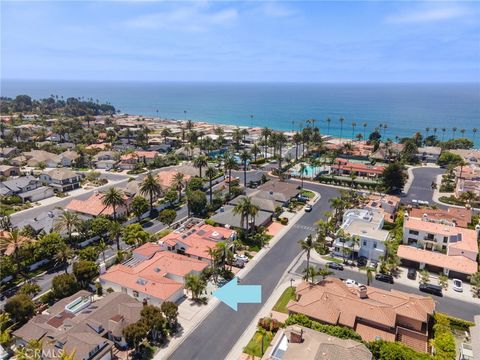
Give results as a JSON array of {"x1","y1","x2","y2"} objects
[{"x1": 171, "y1": 185, "x2": 338, "y2": 360}]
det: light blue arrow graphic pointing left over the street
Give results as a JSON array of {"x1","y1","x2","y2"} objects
[{"x1": 213, "y1": 278, "x2": 262, "y2": 311}]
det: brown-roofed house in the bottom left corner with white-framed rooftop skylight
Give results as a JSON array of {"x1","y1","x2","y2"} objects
[{"x1": 13, "y1": 290, "x2": 143, "y2": 360}]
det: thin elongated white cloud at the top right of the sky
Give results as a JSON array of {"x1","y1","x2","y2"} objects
[{"x1": 386, "y1": 5, "x2": 471, "y2": 24}]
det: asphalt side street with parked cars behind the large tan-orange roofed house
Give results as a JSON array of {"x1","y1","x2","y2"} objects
[{"x1": 294, "y1": 261, "x2": 480, "y2": 321}]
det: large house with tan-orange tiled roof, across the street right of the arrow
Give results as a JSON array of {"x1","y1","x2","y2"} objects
[{"x1": 287, "y1": 278, "x2": 435, "y2": 352}]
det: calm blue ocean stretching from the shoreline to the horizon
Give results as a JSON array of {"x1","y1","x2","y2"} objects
[{"x1": 0, "y1": 80, "x2": 480, "y2": 147}]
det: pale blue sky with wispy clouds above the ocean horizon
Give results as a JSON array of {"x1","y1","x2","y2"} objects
[{"x1": 0, "y1": 0, "x2": 480, "y2": 82}]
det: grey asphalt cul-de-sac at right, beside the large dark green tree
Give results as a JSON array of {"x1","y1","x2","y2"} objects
[{"x1": 401, "y1": 167, "x2": 445, "y2": 207}]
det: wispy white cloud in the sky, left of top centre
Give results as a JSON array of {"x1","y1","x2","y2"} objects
[{"x1": 126, "y1": 6, "x2": 238, "y2": 32}]
